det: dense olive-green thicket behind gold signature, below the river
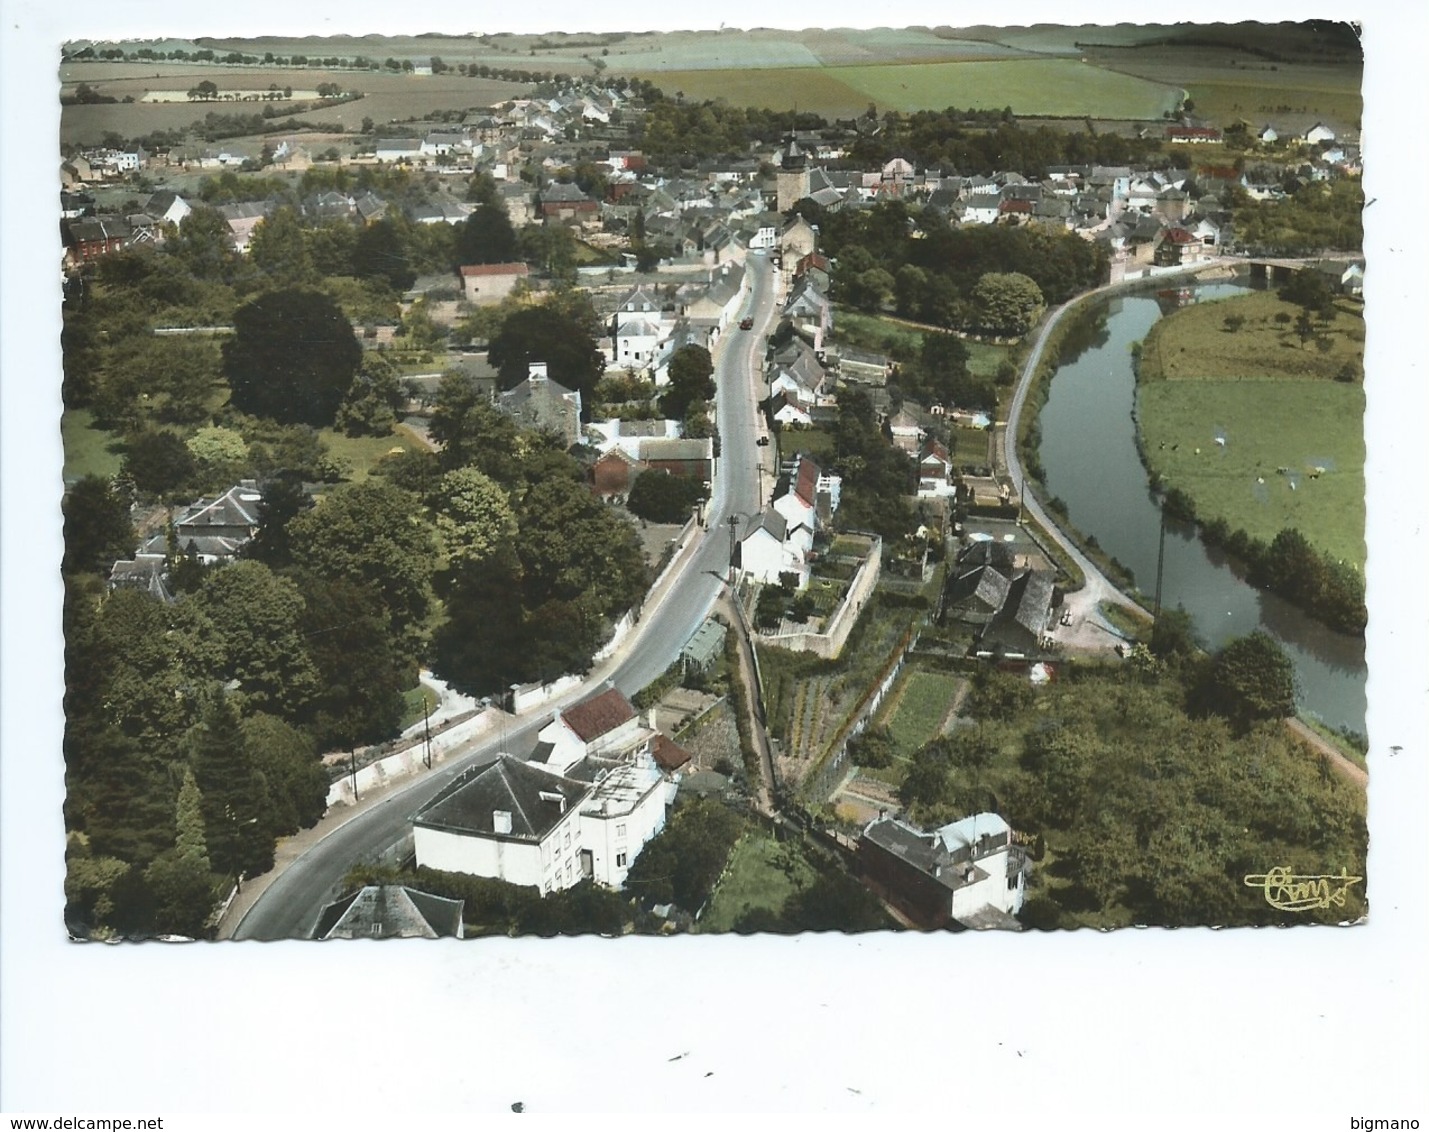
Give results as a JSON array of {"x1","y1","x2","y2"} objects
[{"x1": 902, "y1": 654, "x2": 1368, "y2": 926}]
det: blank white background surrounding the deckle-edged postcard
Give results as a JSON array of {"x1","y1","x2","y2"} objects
[{"x1": 0, "y1": 0, "x2": 1429, "y2": 1129}]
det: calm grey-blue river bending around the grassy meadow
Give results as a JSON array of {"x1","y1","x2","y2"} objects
[{"x1": 1040, "y1": 283, "x2": 1366, "y2": 733}]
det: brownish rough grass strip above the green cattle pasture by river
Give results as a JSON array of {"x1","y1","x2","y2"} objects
[{"x1": 1140, "y1": 292, "x2": 1365, "y2": 383}]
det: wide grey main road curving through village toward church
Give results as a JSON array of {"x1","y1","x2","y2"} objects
[{"x1": 228, "y1": 254, "x2": 776, "y2": 939}]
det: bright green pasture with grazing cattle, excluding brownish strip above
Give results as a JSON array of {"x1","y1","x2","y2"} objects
[{"x1": 1137, "y1": 379, "x2": 1365, "y2": 566}]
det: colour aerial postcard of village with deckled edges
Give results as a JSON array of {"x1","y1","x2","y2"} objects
[{"x1": 54, "y1": 21, "x2": 1375, "y2": 953}]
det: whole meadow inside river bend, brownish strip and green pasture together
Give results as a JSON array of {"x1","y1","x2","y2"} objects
[{"x1": 1136, "y1": 292, "x2": 1365, "y2": 566}]
